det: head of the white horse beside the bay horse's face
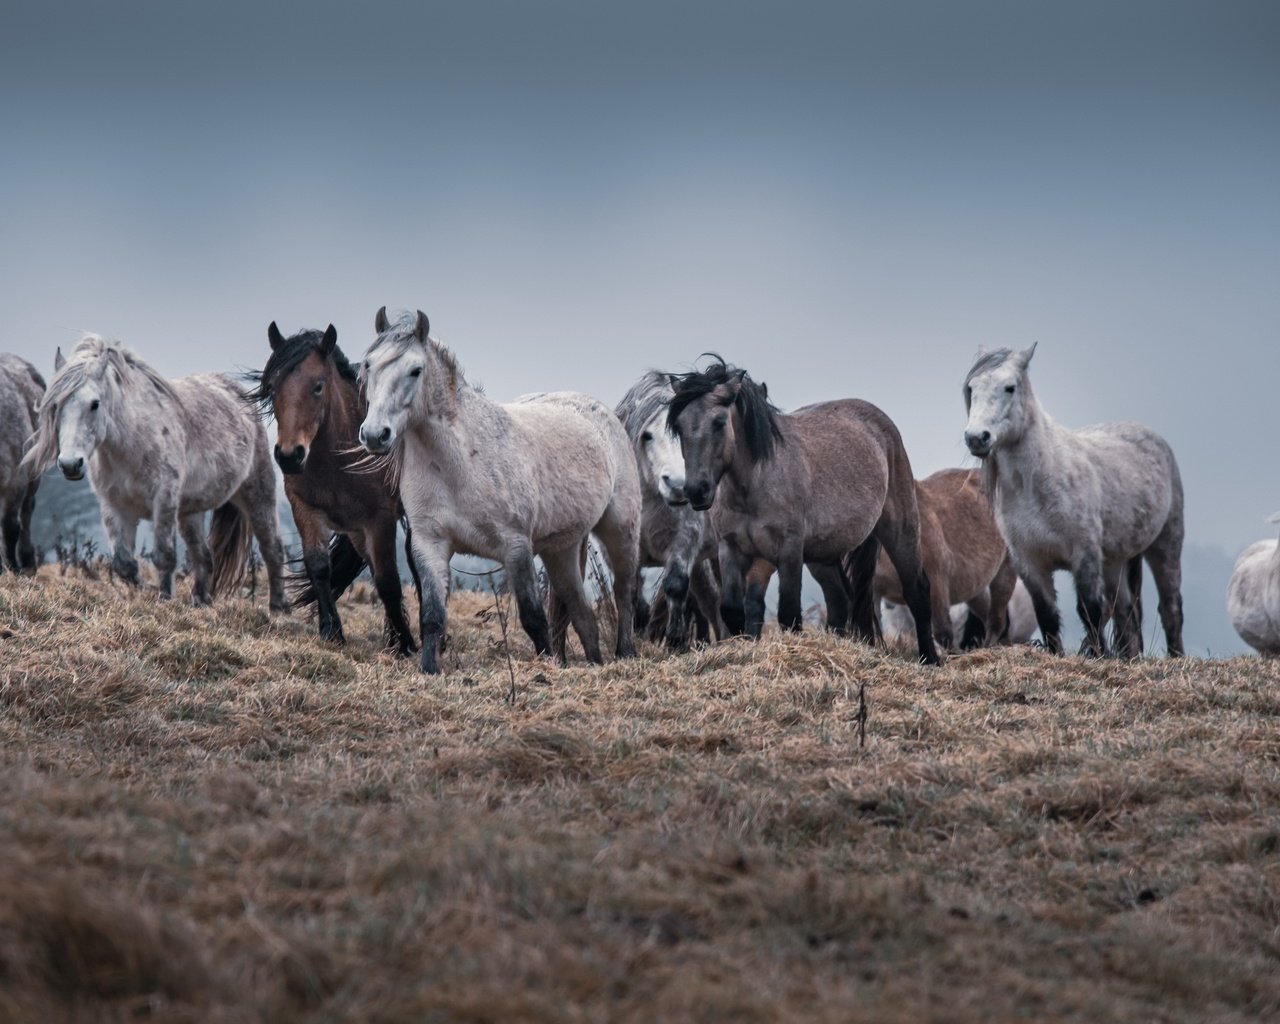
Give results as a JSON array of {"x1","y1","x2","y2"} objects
[{"x1": 360, "y1": 306, "x2": 431, "y2": 454}]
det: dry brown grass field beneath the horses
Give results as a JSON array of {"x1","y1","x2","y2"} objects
[{"x1": 0, "y1": 567, "x2": 1280, "y2": 1021}]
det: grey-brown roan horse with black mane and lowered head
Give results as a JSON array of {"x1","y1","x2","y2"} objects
[{"x1": 668, "y1": 357, "x2": 938, "y2": 664}]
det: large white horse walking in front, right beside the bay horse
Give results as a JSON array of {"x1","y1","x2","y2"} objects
[{"x1": 360, "y1": 307, "x2": 640, "y2": 672}]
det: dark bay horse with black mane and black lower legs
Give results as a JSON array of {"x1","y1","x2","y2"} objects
[{"x1": 250, "y1": 321, "x2": 417, "y2": 657}]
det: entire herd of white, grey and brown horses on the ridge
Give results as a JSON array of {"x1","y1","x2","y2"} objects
[{"x1": 0, "y1": 307, "x2": 1280, "y2": 672}]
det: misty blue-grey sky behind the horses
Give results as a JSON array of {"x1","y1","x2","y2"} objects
[{"x1": 0, "y1": 0, "x2": 1280, "y2": 653}]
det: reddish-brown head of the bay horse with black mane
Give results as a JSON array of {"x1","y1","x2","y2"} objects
[{"x1": 250, "y1": 321, "x2": 356, "y2": 474}]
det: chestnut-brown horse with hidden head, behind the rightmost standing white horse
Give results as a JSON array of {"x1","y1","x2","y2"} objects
[{"x1": 876, "y1": 470, "x2": 1018, "y2": 650}]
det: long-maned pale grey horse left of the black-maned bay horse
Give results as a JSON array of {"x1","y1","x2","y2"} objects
[{"x1": 26, "y1": 334, "x2": 289, "y2": 612}]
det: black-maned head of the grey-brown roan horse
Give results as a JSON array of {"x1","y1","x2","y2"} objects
[{"x1": 667, "y1": 356, "x2": 783, "y2": 512}]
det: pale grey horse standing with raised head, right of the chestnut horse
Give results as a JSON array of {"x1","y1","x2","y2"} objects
[{"x1": 964, "y1": 346, "x2": 1184, "y2": 657}]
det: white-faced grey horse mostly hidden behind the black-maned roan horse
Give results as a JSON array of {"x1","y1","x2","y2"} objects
[{"x1": 616, "y1": 370, "x2": 724, "y2": 648}]
